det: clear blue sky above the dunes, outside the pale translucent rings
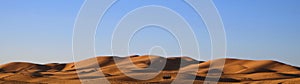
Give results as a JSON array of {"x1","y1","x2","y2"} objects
[{"x1": 0, "y1": 0, "x2": 300, "y2": 66}]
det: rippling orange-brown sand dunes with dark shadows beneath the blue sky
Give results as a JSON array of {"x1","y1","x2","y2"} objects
[{"x1": 0, "y1": 55, "x2": 300, "y2": 84}]
